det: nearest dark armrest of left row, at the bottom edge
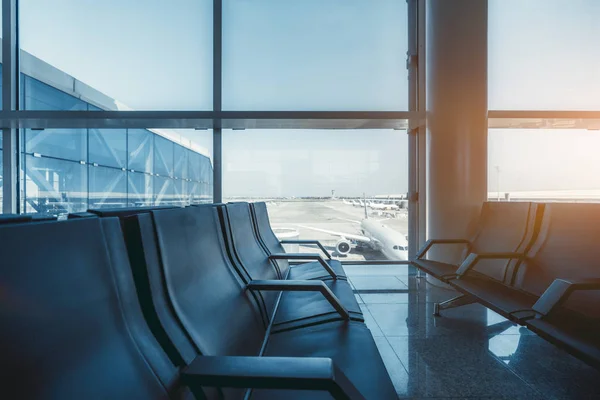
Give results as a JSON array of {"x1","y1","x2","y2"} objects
[{"x1": 181, "y1": 356, "x2": 364, "y2": 400}]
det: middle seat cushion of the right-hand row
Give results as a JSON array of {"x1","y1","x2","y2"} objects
[{"x1": 449, "y1": 273, "x2": 537, "y2": 322}]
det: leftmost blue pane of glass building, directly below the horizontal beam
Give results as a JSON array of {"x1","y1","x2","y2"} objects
[{"x1": 25, "y1": 129, "x2": 87, "y2": 161}]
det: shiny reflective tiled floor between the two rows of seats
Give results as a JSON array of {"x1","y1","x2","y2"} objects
[{"x1": 344, "y1": 265, "x2": 600, "y2": 400}]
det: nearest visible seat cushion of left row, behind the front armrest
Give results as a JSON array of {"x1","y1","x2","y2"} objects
[{"x1": 252, "y1": 322, "x2": 398, "y2": 400}]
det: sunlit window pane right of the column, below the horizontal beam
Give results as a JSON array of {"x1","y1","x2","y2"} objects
[{"x1": 488, "y1": 129, "x2": 600, "y2": 200}]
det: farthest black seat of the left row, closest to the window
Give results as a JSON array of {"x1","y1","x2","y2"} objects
[{"x1": 248, "y1": 202, "x2": 346, "y2": 279}]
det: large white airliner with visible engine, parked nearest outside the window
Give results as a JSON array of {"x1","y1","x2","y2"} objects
[{"x1": 298, "y1": 203, "x2": 408, "y2": 261}]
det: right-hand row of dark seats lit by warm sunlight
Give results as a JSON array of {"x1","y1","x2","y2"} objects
[{"x1": 412, "y1": 202, "x2": 600, "y2": 369}]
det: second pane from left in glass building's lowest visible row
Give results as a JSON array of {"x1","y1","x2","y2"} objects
[{"x1": 89, "y1": 165, "x2": 127, "y2": 208}]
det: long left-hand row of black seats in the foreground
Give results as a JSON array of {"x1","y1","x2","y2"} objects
[{"x1": 0, "y1": 203, "x2": 397, "y2": 399}]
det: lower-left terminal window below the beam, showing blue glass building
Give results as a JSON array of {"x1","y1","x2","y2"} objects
[{"x1": 21, "y1": 125, "x2": 212, "y2": 214}]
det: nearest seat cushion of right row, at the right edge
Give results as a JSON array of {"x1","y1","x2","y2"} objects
[{"x1": 526, "y1": 317, "x2": 600, "y2": 369}]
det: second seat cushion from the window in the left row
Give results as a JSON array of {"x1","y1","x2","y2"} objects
[{"x1": 273, "y1": 279, "x2": 364, "y2": 331}]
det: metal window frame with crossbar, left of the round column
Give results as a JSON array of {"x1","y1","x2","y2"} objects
[{"x1": 0, "y1": 0, "x2": 418, "y2": 263}]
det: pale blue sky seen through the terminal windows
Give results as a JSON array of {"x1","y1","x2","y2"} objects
[{"x1": 14, "y1": 0, "x2": 600, "y2": 195}]
